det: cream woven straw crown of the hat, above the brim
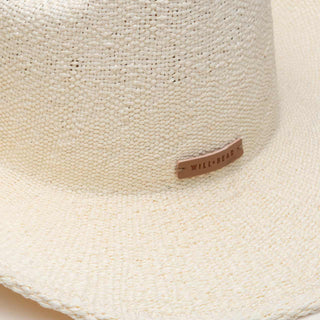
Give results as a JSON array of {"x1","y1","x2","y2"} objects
[{"x1": 0, "y1": 0, "x2": 276, "y2": 192}]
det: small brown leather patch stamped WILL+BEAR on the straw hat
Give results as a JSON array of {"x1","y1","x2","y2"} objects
[{"x1": 176, "y1": 139, "x2": 243, "y2": 179}]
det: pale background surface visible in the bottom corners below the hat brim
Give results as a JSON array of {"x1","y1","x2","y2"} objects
[{"x1": 0, "y1": 285, "x2": 320, "y2": 320}]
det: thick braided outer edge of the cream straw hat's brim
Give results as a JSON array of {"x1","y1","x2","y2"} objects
[{"x1": 0, "y1": 261, "x2": 320, "y2": 320}]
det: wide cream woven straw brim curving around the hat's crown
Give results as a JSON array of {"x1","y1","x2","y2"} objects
[{"x1": 0, "y1": 0, "x2": 320, "y2": 320}]
